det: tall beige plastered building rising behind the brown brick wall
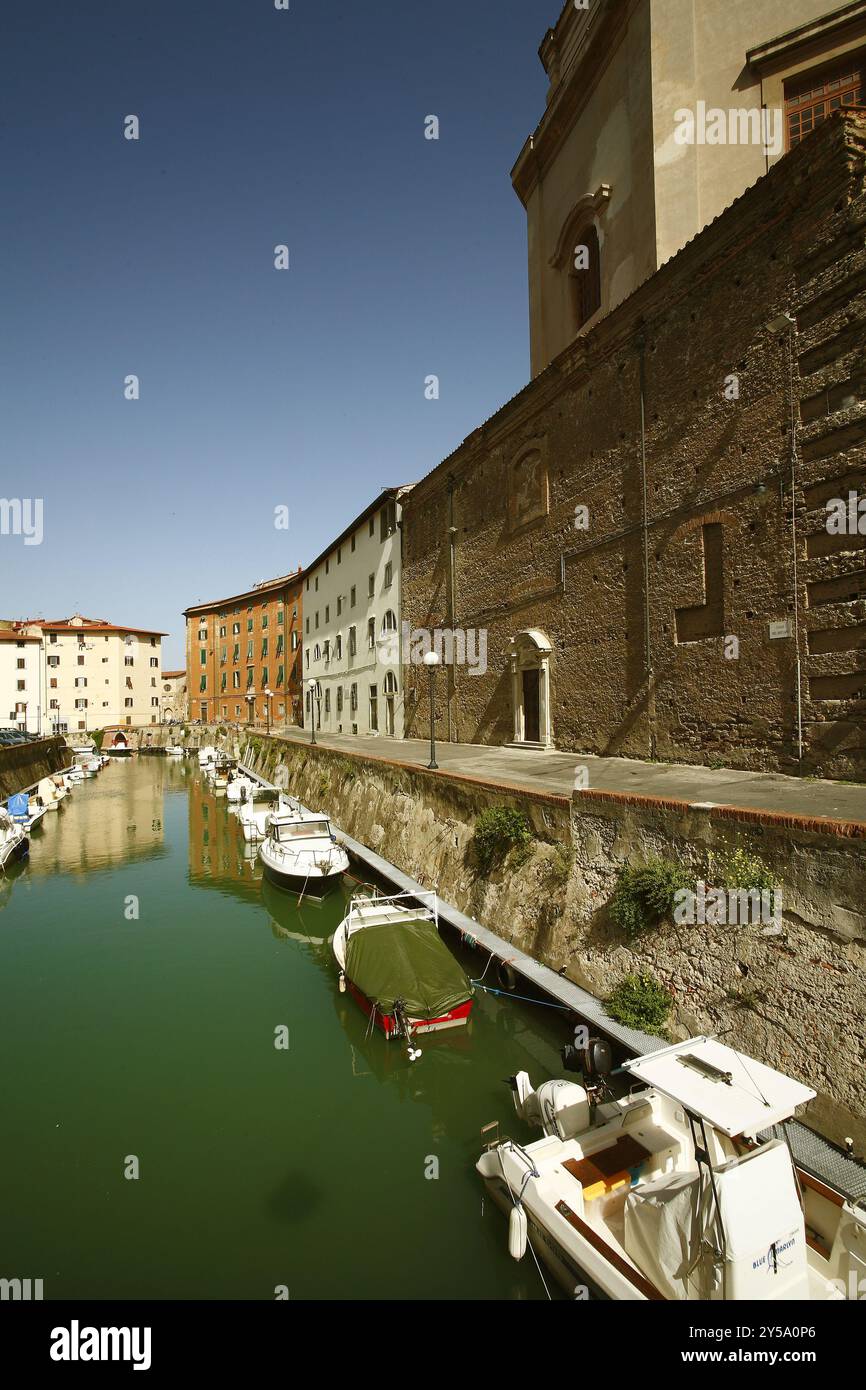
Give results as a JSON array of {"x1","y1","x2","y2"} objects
[{"x1": 512, "y1": 0, "x2": 866, "y2": 377}]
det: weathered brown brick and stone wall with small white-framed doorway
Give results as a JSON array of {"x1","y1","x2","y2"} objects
[{"x1": 403, "y1": 111, "x2": 866, "y2": 777}]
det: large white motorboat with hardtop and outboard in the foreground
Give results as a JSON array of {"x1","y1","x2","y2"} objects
[{"x1": 477, "y1": 1037, "x2": 866, "y2": 1301}]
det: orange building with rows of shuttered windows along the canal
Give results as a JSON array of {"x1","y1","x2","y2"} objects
[{"x1": 183, "y1": 569, "x2": 303, "y2": 726}]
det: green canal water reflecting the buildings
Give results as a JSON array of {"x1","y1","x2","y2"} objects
[{"x1": 0, "y1": 758, "x2": 566, "y2": 1300}]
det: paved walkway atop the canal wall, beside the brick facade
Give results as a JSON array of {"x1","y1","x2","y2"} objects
[{"x1": 256, "y1": 727, "x2": 866, "y2": 821}]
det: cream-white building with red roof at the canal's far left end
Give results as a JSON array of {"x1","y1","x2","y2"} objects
[{"x1": 0, "y1": 613, "x2": 165, "y2": 737}]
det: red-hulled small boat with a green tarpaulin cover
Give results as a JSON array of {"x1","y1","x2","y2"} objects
[{"x1": 334, "y1": 892, "x2": 474, "y2": 1062}]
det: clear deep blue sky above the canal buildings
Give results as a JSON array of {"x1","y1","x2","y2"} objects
[{"x1": 0, "y1": 0, "x2": 547, "y2": 667}]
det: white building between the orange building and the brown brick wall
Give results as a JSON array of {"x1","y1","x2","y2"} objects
[{"x1": 303, "y1": 488, "x2": 409, "y2": 738}]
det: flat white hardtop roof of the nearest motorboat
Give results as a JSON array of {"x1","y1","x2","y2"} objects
[{"x1": 626, "y1": 1037, "x2": 815, "y2": 1138}]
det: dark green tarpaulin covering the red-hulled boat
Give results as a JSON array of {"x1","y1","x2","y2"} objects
[{"x1": 346, "y1": 917, "x2": 474, "y2": 1019}]
